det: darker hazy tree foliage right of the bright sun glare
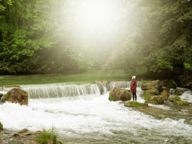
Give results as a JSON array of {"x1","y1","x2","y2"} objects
[{"x1": 117, "y1": 0, "x2": 192, "y2": 73}]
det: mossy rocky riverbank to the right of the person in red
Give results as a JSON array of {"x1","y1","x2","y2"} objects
[{"x1": 109, "y1": 80, "x2": 192, "y2": 125}]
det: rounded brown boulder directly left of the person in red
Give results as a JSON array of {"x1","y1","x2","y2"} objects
[{"x1": 109, "y1": 88, "x2": 131, "y2": 101}]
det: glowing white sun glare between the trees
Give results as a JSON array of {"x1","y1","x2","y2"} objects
[{"x1": 51, "y1": 0, "x2": 138, "y2": 68}]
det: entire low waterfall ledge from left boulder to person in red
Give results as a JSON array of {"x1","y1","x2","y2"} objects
[{"x1": 21, "y1": 81, "x2": 130, "y2": 99}]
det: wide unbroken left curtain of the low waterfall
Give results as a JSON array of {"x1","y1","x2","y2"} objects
[{"x1": 21, "y1": 84, "x2": 100, "y2": 98}]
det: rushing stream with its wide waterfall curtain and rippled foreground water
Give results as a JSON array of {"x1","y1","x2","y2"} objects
[{"x1": 0, "y1": 84, "x2": 192, "y2": 144}]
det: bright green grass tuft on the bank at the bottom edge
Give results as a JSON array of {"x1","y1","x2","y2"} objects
[{"x1": 36, "y1": 130, "x2": 57, "y2": 144}]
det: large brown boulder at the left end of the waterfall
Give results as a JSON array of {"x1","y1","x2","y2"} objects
[{"x1": 1, "y1": 88, "x2": 28, "y2": 105}]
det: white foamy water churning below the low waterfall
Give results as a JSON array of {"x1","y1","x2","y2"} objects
[{"x1": 0, "y1": 94, "x2": 192, "y2": 138}]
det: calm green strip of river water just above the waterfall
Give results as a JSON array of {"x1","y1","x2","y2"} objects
[{"x1": 0, "y1": 71, "x2": 130, "y2": 86}]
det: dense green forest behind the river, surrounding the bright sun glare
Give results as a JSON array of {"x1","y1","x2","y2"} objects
[{"x1": 0, "y1": 0, "x2": 192, "y2": 74}]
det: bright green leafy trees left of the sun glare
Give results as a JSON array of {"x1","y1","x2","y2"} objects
[{"x1": 0, "y1": 0, "x2": 83, "y2": 74}]
